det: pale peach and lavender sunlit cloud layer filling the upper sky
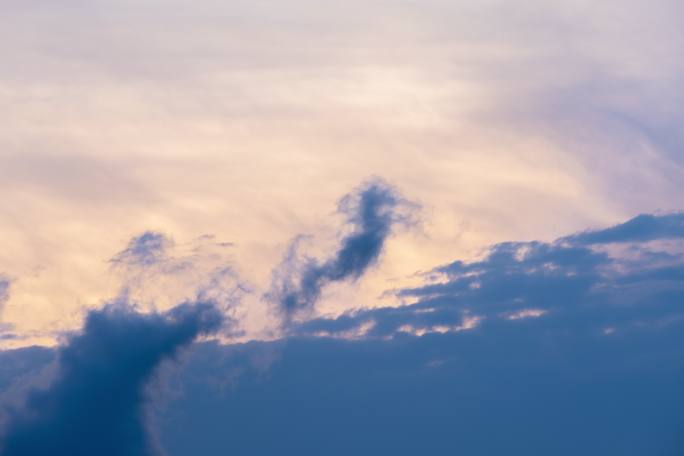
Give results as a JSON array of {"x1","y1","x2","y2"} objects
[{"x1": 0, "y1": 0, "x2": 684, "y2": 342}]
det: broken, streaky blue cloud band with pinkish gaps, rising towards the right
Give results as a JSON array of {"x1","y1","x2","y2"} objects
[{"x1": 299, "y1": 214, "x2": 684, "y2": 337}]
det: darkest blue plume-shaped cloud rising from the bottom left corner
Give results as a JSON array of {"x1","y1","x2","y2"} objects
[{"x1": 2, "y1": 303, "x2": 223, "y2": 456}]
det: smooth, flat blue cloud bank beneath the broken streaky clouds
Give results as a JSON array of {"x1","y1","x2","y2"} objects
[{"x1": 162, "y1": 326, "x2": 684, "y2": 456}]
